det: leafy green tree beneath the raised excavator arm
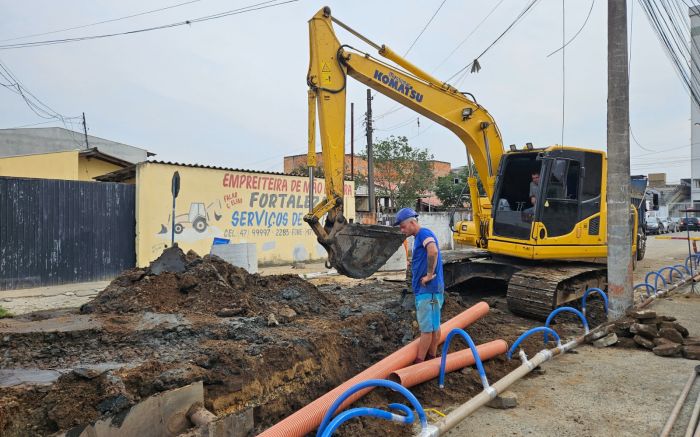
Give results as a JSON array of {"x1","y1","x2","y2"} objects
[{"x1": 355, "y1": 135, "x2": 435, "y2": 208}]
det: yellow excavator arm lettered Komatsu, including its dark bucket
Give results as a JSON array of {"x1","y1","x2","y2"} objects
[{"x1": 304, "y1": 7, "x2": 503, "y2": 277}]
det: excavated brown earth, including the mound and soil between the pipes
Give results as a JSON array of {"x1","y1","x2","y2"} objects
[{"x1": 0, "y1": 247, "x2": 600, "y2": 436}]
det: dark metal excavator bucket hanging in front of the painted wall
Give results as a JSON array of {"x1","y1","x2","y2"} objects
[{"x1": 323, "y1": 223, "x2": 406, "y2": 278}]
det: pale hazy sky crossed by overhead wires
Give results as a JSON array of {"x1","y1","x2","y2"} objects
[{"x1": 0, "y1": 0, "x2": 690, "y2": 182}]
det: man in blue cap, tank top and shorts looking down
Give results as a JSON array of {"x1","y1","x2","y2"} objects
[{"x1": 394, "y1": 208, "x2": 445, "y2": 363}]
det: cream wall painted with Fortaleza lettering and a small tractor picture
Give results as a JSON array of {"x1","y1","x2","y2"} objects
[{"x1": 136, "y1": 163, "x2": 355, "y2": 266}]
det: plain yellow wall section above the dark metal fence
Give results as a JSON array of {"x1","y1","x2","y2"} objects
[{"x1": 0, "y1": 150, "x2": 78, "y2": 180}]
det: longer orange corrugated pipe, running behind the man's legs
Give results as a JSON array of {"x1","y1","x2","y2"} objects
[{"x1": 254, "y1": 302, "x2": 489, "y2": 437}]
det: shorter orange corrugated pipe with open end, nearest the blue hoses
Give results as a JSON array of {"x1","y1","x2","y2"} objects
[{"x1": 389, "y1": 340, "x2": 508, "y2": 388}]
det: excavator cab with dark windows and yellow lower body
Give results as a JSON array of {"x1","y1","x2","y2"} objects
[{"x1": 489, "y1": 147, "x2": 605, "y2": 255}]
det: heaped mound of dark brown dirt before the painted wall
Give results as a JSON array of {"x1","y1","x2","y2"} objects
[{"x1": 81, "y1": 247, "x2": 335, "y2": 318}]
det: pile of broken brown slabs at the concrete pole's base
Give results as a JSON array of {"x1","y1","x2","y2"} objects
[{"x1": 613, "y1": 310, "x2": 700, "y2": 360}]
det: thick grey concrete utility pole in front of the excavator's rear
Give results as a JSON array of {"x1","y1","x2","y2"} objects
[{"x1": 607, "y1": 0, "x2": 634, "y2": 320}]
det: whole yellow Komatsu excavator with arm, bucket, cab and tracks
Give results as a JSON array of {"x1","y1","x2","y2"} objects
[{"x1": 304, "y1": 7, "x2": 643, "y2": 318}]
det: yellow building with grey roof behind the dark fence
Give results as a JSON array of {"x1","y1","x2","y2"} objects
[{"x1": 0, "y1": 127, "x2": 153, "y2": 181}]
